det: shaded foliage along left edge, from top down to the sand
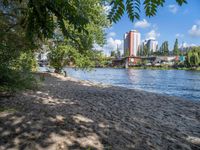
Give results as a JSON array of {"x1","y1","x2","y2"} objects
[{"x1": 0, "y1": 1, "x2": 37, "y2": 92}]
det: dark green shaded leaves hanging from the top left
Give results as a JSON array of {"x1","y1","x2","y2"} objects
[{"x1": 2, "y1": 0, "x2": 89, "y2": 40}]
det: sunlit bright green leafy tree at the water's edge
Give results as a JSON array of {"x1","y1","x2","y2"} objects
[{"x1": 49, "y1": 0, "x2": 109, "y2": 73}]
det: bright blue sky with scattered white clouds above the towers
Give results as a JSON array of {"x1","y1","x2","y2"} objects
[{"x1": 103, "y1": 0, "x2": 200, "y2": 54}]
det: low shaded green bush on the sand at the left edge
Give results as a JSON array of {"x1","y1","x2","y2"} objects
[{"x1": 0, "y1": 51, "x2": 37, "y2": 92}]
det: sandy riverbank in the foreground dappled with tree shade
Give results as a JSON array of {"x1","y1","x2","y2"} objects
[{"x1": 0, "y1": 74, "x2": 200, "y2": 150}]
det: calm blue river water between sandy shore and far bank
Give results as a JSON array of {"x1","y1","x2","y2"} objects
[{"x1": 66, "y1": 68, "x2": 200, "y2": 101}]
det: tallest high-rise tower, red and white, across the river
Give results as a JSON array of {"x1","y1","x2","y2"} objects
[{"x1": 124, "y1": 30, "x2": 141, "y2": 56}]
